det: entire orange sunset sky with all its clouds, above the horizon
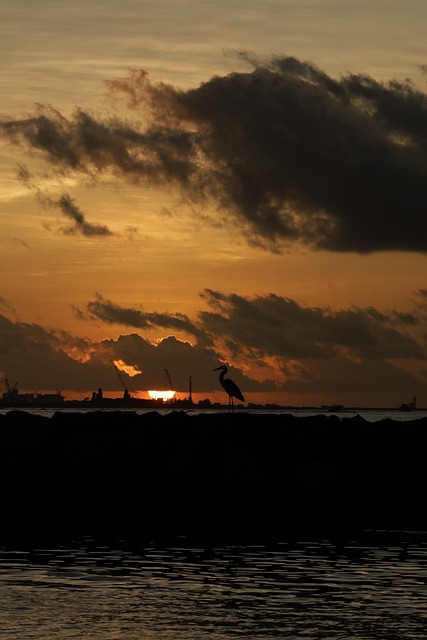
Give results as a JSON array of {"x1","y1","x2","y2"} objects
[{"x1": 0, "y1": 0, "x2": 427, "y2": 407}]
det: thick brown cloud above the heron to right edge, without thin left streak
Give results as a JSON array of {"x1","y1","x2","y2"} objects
[{"x1": 200, "y1": 289, "x2": 426, "y2": 361}]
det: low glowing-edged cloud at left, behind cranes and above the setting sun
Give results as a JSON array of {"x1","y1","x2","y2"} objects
[{"x1": 0, "y1": 314, "x2": 260, "y2": 397}]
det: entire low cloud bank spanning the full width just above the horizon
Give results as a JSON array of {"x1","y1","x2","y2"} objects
[{"x1": 0, "y1": 290, "x2": 427, "y2": 406}]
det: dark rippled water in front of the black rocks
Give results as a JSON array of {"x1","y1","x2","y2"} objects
[{"x1": 0, "y1": 532, "x2": 427, "y2": 640}]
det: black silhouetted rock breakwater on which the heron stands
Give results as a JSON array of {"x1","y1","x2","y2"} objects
[{"x1": 0, "y1": 411, "x2": 427, "y2": 544}]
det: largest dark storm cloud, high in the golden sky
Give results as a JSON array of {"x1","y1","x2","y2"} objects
[{"x1": 1, "y1": 55, "x2": 427, "y2": 253}]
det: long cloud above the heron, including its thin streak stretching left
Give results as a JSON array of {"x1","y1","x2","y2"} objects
[{"x1": 75, "y1": 289, "x2": 427, "y2": 362}]
